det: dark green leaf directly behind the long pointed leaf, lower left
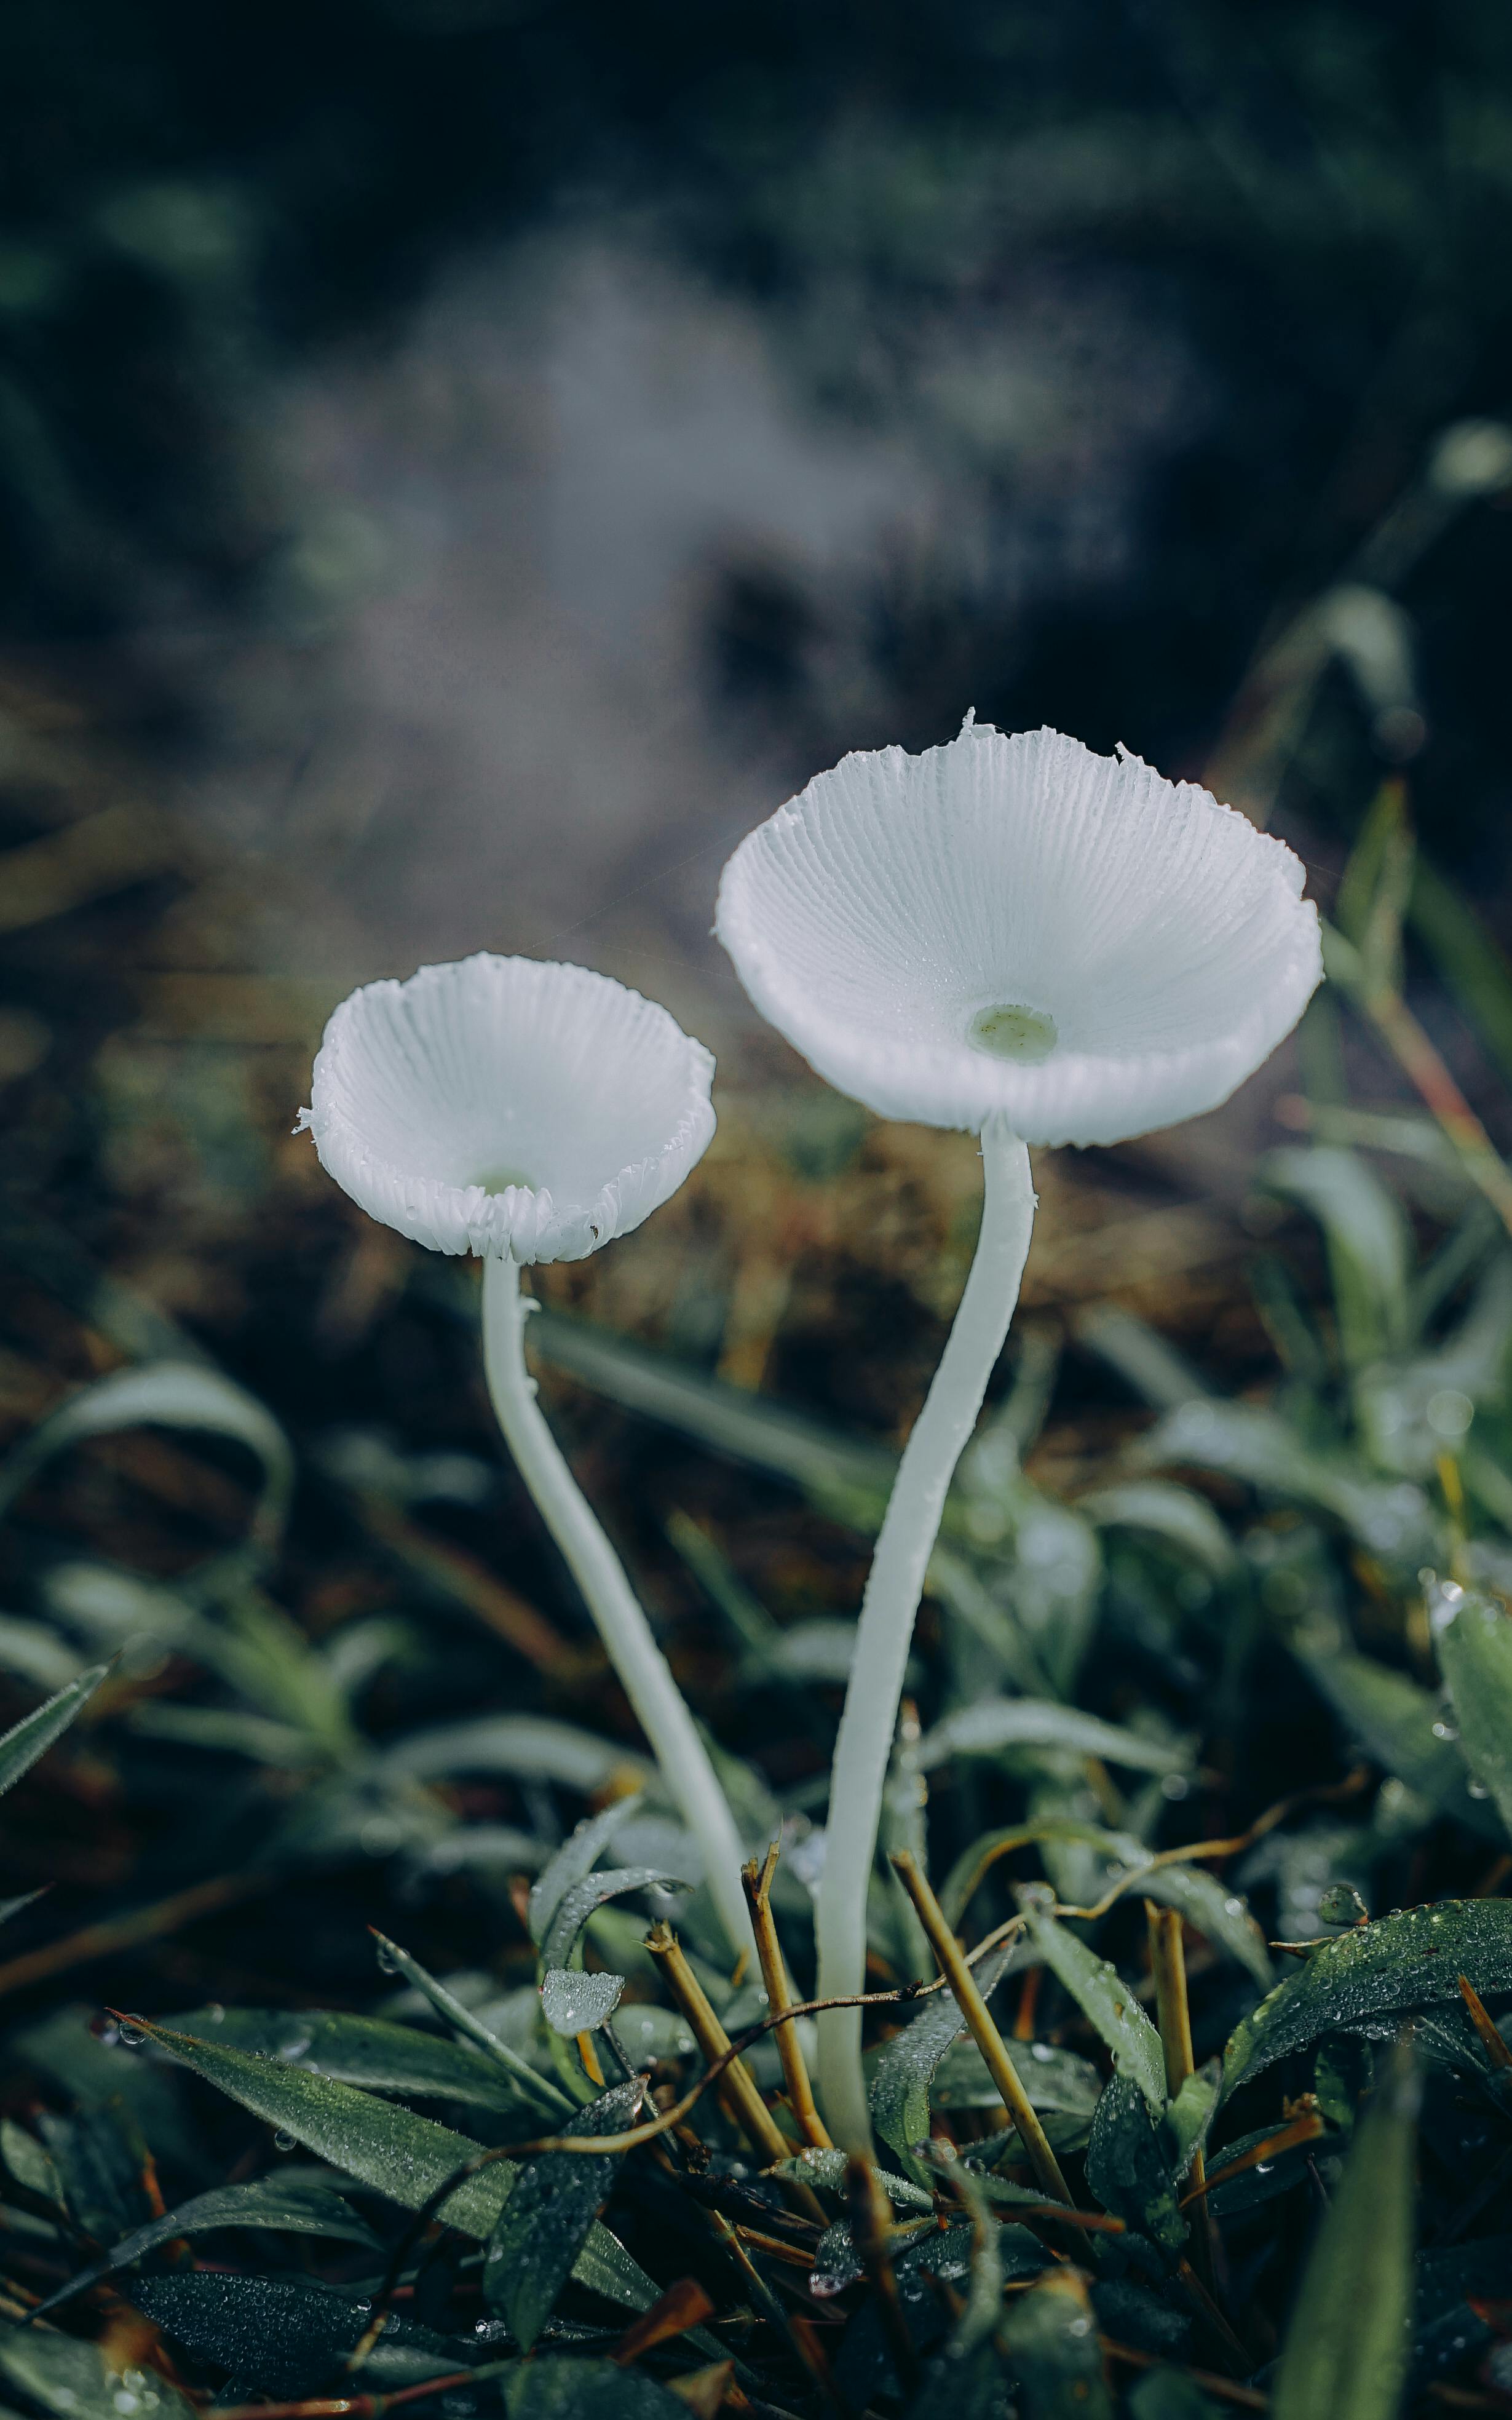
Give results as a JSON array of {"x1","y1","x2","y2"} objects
[{"x1": 165, "y1": 2009, "x2": 569, "y2": 2115}]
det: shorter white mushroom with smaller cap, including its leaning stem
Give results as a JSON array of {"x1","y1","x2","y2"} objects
[{"x1": 300, "y1": 953, "x2": 753, "y2": 1953}]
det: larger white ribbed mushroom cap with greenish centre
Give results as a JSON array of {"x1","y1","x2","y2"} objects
[{"x1": 714, "y1": 716, "x2": 1323, "y2": 1142}]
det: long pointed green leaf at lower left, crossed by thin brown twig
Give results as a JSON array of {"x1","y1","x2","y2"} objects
[{"x1": 135, "y1": 2018, "x2": 655, "y2": 2311}]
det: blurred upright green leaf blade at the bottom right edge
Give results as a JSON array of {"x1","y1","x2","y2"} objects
[{"x1": 1270, "y1": 2050, "x2": 1418, "y2": 2420}]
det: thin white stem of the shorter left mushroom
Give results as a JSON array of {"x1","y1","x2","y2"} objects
[{"x1": 484, "y1": 1253, "x2": 755, "y2": 1955}]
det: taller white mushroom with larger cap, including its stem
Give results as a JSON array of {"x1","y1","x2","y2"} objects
[{"x1": 716, "y1": 714, "x2": 1321, "y2": 2151}]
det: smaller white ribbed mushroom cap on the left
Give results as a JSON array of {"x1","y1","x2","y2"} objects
[{"x1": 300, "y1": 951, "x2": 714, "y2": 1261}]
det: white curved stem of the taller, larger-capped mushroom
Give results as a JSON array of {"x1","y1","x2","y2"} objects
[{"x1": 818, "y1": 1116, "x2": 1035, "y2": 2156}]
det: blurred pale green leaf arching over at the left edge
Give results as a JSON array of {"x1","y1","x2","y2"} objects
[{"x1": 0, "y1": 1360, "x2": 295, "y2": 1553}]
